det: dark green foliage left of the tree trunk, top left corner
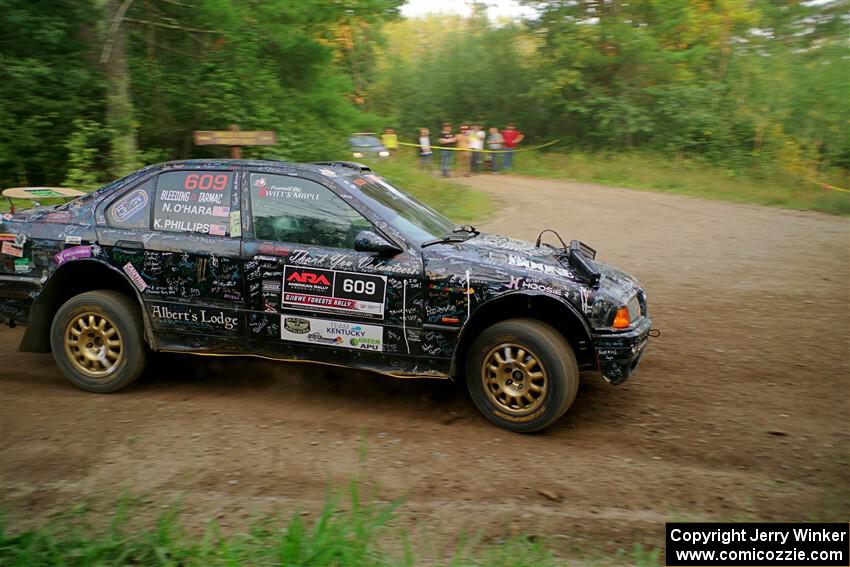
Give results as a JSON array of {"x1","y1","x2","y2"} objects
[{"x1": 0, "y1": 0, "x2": 104, "y2": 186}]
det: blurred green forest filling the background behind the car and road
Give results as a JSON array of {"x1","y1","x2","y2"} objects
[{"x1": 0, "y1": 0, "x2": 850, "y2": 202}]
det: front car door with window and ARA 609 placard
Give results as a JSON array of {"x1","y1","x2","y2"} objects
[{"x1": 238, "y1": 170, "x2": 423, "y2": 371}]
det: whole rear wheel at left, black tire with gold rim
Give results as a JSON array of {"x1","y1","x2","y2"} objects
[{"x1": 50, "y1": 290, "x2": 146, "y2": 394}]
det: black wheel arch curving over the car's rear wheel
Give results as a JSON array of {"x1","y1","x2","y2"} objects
[{"x1": 18, "y1": 258, "x2": 156, "y2": 352}]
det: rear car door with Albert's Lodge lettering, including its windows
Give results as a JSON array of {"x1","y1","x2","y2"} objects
[{"x1": 98, "y1": 167, "x2": 246, "y2": 351}]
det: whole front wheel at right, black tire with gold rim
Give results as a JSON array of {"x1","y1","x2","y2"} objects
[{"x1": 466, "y1": 319, "x2": 579, "y2": 433}]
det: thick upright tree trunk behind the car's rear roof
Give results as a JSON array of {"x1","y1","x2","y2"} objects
[{"x1": 101, "y1": 0, "x2": 138, "y2": 175}]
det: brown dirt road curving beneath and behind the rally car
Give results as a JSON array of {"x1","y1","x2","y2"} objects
[{"x1": 0, "y1": 176, "x2": 850, "y2": 560}]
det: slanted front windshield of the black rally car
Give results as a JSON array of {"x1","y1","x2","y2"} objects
[{"x1": 342, "y1": 174, "x2": 455, "y2": 245}]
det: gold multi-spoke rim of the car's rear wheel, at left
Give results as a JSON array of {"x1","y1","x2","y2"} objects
[{"x1": 65, "y1": 311, "x2": 124, "y2": 380}]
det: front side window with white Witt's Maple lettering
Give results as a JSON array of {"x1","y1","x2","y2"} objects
[{"x1": 250, "y1": 173, "x2": 372, "y2": 248}]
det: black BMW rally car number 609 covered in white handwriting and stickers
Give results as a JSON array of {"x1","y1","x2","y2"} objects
[{"x1": 0, "y1": 160, "x2": 651, "y2": 431}]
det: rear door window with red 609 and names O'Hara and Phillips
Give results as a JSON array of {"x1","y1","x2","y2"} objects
[{"x1": 153, "y1": 171, "x2": 234, "y2": 236}]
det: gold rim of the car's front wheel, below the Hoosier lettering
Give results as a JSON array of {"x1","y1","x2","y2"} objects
[{"x1": 481, "y1": 343, "x2": 549, "y2": 416}]
